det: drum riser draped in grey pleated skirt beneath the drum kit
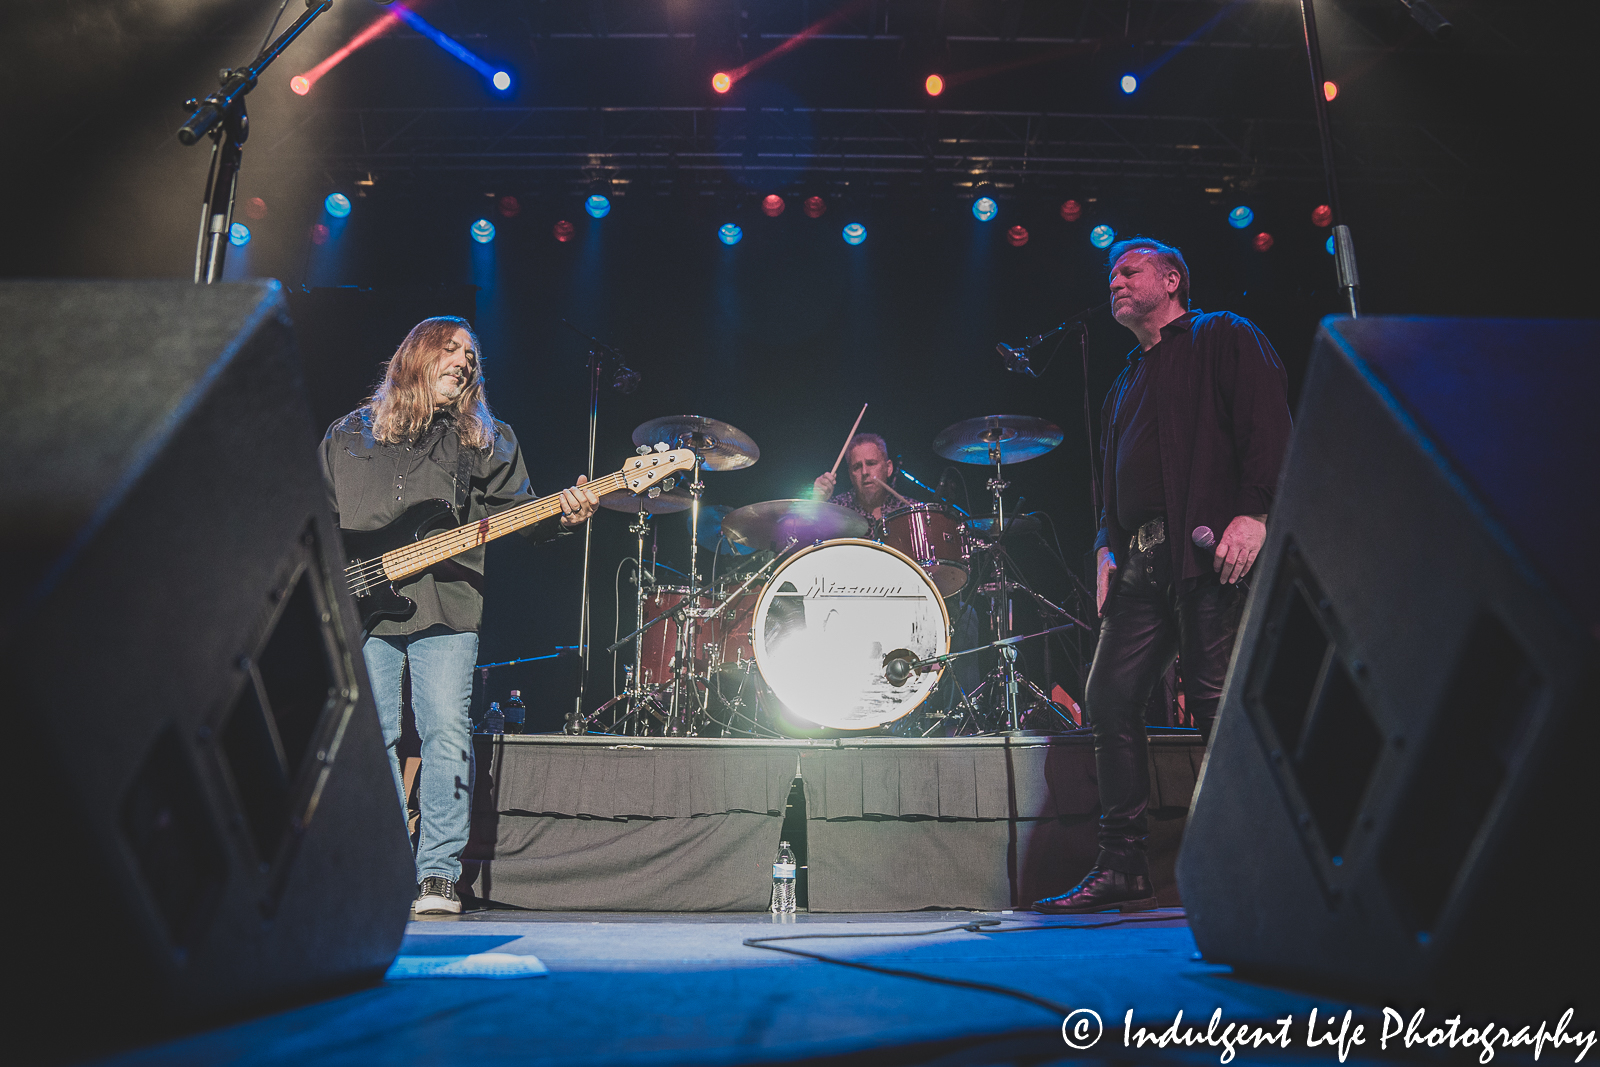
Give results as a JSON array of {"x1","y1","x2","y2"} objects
[{"x1": 462, "y1": 731, "x2": 1203, "y2": 912}]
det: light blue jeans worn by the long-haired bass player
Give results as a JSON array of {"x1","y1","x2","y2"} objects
[{"x1": 362, "y1": 627, "x2": 478, "y2": 883}]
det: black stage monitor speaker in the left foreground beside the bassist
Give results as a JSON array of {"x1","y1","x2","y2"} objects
[{"x1": 0, "y1": 282, "x2": 414, "y2": 1048}]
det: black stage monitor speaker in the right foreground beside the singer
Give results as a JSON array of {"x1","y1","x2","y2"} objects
[{"x1": 1178, "y1": 318, "x2": 1600, "y2": 1024}]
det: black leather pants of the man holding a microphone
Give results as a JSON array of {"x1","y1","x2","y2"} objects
[{"x1": 1083, "y1": 544, "x2": 1245, "y2": 875}]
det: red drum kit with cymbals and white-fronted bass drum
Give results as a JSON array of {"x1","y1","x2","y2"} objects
[{"x1": 566, "y1": 416, "x2": 1083, "y2": 737}]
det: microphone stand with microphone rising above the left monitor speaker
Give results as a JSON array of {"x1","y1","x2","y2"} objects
[{"x1": 178, "y1": 0, "x2": 333, "y2": 285}]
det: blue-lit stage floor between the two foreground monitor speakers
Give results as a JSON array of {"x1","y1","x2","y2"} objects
[{"x1": 81, "y1": 910, "x2": 1529, "y2": 1067}]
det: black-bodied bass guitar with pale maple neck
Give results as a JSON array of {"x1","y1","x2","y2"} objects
[{"x1": 339, "y1": 448, "x2": 694, "y2": 633}]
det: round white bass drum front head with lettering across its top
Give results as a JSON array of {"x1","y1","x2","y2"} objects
[{"x1": 752, "y1": 537, "x2": 950, "y2": 729}]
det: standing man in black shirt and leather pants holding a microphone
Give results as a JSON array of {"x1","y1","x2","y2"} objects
[{"x1": 1034, "y1": 237, "x2": 1290, "y2": 912}]
